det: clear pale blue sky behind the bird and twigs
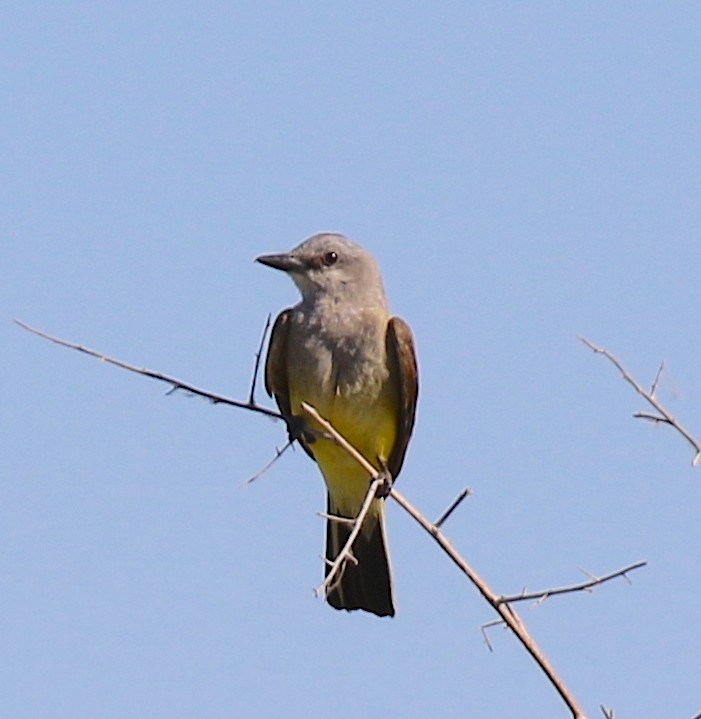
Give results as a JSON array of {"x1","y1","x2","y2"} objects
[{"x1": 0, "y1": 5, "x2": 701, "y2": 719}]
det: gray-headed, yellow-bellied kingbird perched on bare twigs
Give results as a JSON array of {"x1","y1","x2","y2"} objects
[{"x1": 256, "y1": 234, "x2": 418, "y2": 617}]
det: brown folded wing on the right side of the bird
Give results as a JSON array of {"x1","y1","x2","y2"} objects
[{"x1": 385, "y1": 317, "x2": 419, "y2": 479}]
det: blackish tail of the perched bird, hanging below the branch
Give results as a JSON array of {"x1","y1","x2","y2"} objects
[{"x1": 326, "y1": 497, "x2": 394, "y2": 617}]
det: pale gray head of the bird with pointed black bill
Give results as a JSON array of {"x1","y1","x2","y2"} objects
[{"x1": 256, "y1": 233, "x2": 385, "y2": 305}]
